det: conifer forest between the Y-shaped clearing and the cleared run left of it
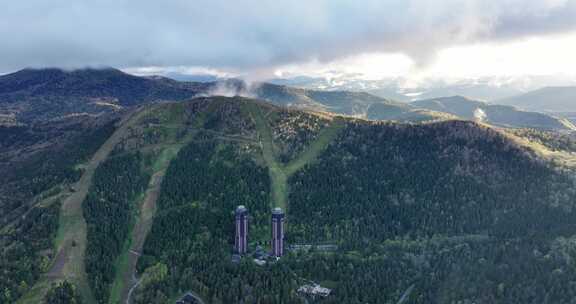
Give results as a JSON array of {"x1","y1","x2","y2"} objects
[{"x1": 137, "y1": 136, "x2": 295, "y2": 303}]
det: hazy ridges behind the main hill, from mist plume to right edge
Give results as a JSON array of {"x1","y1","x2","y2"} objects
[{"x1": 201, "y1": 80, "x2": 575, "y2": 130}]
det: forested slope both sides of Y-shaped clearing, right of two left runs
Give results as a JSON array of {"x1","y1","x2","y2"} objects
[{"x1": 130, "y1": 98, "x2": 576, "y2": 303}]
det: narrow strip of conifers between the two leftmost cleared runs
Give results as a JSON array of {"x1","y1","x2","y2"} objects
[{"x1": 83, "y1": 154, "x2": 150, "y2": 303}]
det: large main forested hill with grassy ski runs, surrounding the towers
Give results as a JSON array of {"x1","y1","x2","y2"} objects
[{"x1": 0, "y1": 97, "x2": 576, "y2": 303}]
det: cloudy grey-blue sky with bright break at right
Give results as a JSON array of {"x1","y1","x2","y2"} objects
[{"x1": 0, "y1": 0, "x2": 576, "y2": 78}]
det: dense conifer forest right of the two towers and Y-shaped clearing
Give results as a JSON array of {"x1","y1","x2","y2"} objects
[{"x1": 288, "y1": 122, "x2": 576, "y2": 303}]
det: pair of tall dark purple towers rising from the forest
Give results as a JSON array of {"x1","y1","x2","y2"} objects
[{"x1": 234, "y1": 205, "x2": 284, "y2": 257}]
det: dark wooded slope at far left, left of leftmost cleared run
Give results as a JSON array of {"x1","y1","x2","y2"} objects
[{"x1": 0, "y1": 115, "x2": 120, "y2": 224}]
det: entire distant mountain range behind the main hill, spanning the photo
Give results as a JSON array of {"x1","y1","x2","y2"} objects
[{"x1": 0, "y1": 68, "x2": 576, "y2": 130}]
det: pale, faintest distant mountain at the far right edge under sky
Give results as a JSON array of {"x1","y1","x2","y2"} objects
[{"x1": 498, "y1": 87, "x2": 576, "y2": 113}]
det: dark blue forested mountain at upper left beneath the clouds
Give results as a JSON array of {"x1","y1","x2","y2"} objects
[{"x1": 0, "y1": 68, "x2": 205, "y2": 123}]
